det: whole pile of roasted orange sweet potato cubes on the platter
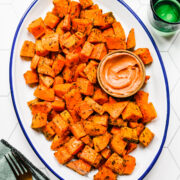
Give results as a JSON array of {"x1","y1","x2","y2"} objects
[{"x1": 21, "y1": 0, "x2": 157, "y2": 180}]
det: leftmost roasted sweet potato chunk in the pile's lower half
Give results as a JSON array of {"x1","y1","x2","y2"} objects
[{"x1": 31, "y1": 101, "x2": 52, "y2": 115}]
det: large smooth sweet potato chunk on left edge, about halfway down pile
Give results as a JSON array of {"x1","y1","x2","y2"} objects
[{"x1": 34, "y1": 85, "x2": 55, "y2": 101}]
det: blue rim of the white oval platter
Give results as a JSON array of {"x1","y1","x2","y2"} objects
[{"x1": 9, "y1": 0, "x2": 170, "y2": 180}]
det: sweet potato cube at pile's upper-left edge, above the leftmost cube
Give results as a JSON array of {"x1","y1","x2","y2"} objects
[{"x1": 28, "y1": 18, "x2": 45, "y2": 39}]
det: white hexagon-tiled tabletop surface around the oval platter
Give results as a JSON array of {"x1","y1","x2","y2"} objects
[{"x1": 0, "y1": 0, "x2": 180, "y2": 180}]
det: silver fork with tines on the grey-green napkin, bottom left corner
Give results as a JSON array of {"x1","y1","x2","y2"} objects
[{"x1": 5, "y1": 151, "x2": 31, "y2": 179}]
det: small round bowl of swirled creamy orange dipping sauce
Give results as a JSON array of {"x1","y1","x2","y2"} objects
[{"x1": 99, "y1": 52, "x2": 145, "y2": 96}]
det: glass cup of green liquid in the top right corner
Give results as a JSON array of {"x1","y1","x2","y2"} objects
[{"x1": 148, "y1": 0, "x2": 180, "y2": 33}]
